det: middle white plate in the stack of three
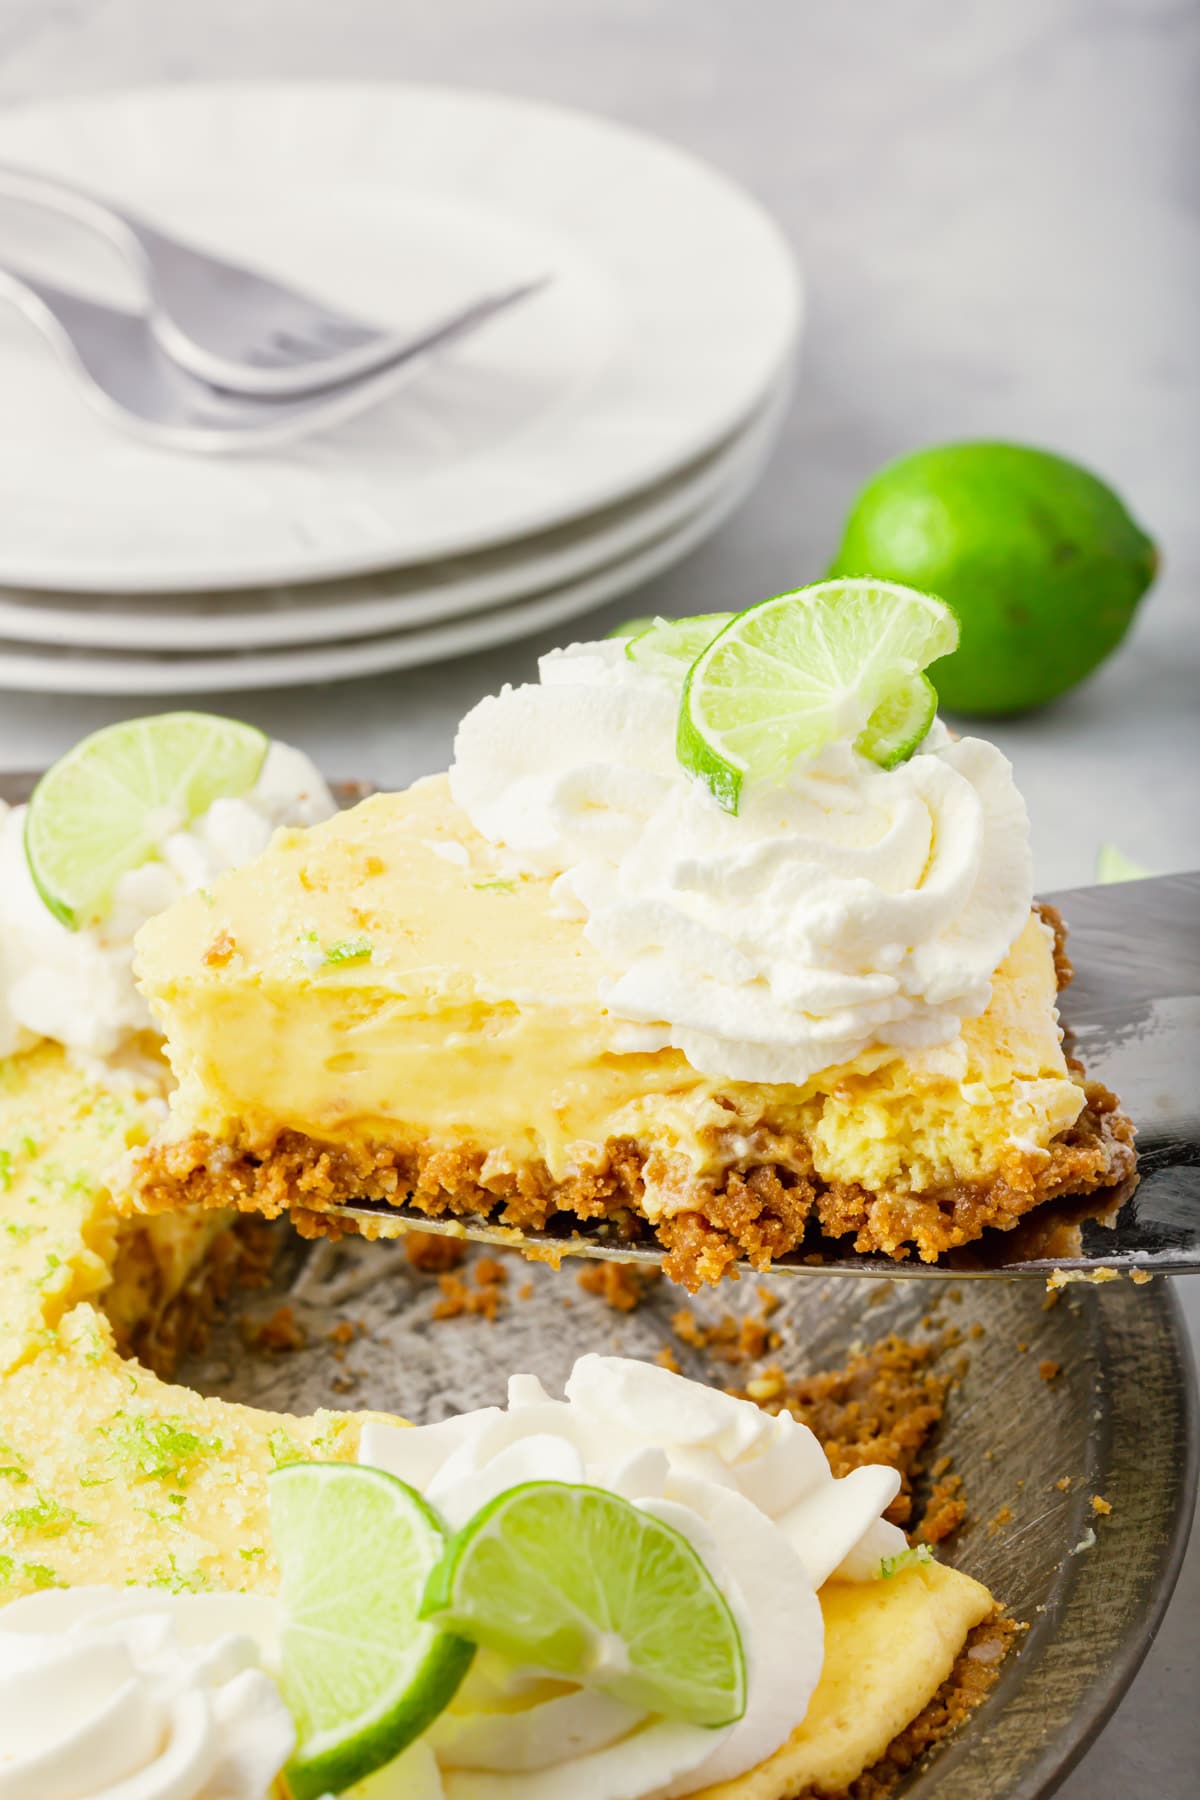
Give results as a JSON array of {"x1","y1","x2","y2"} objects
[{"x1": 0, "y1": 383, "x2": 788, "y2": 653}]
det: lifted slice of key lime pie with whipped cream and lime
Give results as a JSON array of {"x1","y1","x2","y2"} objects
[{"x1": 135, "y1": 581, "x2": 1133, "y2": 1287}]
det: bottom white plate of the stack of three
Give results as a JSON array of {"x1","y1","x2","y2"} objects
[{"x1": 0, "y1": 424, "x2": 765, "y2": 697}]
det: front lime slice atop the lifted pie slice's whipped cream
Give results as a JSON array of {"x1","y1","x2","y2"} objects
[{"x1": 676, "y1": 580, "x2": 959, "y2": 812}]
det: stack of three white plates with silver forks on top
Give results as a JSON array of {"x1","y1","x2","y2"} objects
[{"x1": 0, "y1": 85, "x2": 801, "y2": 693}]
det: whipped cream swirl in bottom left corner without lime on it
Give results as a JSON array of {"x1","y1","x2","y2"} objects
[{"x1": 0, "y1": 1588, "x2": 295, "y2": 1800}]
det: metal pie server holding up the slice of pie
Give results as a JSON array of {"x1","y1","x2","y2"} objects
[{"x1": 340, "y1": 871, "x2": 1200, "y2": 1280}]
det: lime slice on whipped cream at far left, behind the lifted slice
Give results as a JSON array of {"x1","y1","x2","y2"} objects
[{"x1": 25, "y1": 713, "x2": 268, "y2": 931}]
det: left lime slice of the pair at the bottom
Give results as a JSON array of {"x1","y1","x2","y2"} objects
[{"x1": 270, "y1": 1462, "x2": 475, "y2": 1800}]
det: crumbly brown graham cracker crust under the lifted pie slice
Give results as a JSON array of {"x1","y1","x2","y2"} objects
[{"x1": 133, "y1": 1082, "x2": 1135, "y2": 1292}]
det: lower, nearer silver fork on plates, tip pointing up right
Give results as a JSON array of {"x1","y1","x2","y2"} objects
[{"x1": 0, "y1": 263, "x2": 542, "y2": 454}]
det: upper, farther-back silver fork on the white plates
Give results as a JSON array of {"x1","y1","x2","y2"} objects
[{"x1": 0, "y1": 164, "x2": 426, "y2": 398}]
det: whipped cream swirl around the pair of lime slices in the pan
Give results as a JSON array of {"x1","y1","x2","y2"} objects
[{"x1": 360, "y1": 1355, "x2": 905, "y2": 1800}]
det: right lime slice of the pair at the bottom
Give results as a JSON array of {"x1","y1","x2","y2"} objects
[{"x1": 421, "y1": 1481, "x2": 747, "y2": 1726}]
